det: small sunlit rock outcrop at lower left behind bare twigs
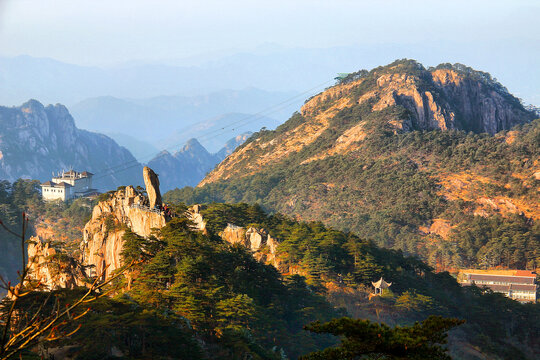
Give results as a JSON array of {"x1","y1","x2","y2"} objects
[{"x1": 28, "y1": 236, "x2": 88, "y2": 290}]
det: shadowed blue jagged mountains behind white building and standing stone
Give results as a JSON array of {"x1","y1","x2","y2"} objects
[{"x1": 0, "y1": 100, "x2": 251, "y2": 191}]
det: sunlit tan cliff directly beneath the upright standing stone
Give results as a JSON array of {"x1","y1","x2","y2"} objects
[{"x1": 80, "y1": 186, "x2": 167, "y2": 278}]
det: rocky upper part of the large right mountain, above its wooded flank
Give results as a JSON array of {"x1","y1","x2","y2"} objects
[{"x1": 199, "y1": 59, "x2": 535, "y2": 186}]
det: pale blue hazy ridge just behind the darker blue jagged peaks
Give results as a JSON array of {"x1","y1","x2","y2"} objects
[{"x1": 70, "y1": 88, "x2": 296, "y2": 144}]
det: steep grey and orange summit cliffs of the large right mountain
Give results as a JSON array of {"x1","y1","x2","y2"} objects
[{"x1": 373, "y1": 69, "x2": 533, "y2": 135}]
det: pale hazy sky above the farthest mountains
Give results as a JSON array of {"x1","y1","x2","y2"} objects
[{"x1": 0, "y1": 0, "x2": 540, "y2": 65}]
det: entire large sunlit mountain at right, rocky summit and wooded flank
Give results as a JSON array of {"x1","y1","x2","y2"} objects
[{"x1": 166, "y1": 60, "x2": 540, "y2": 270}]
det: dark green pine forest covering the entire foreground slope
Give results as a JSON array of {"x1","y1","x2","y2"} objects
[{"x1": 0, "y1": 187, "x2": 540, "y2": 359}]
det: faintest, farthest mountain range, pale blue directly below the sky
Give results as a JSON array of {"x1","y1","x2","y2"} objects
[{"x1": 0, "y1": 41, "x2": 540, "y2": 105}]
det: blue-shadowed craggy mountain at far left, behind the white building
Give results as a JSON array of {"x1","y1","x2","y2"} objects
[{"x1": 0, "y1": 100, "x2": 142, "y2": 191}]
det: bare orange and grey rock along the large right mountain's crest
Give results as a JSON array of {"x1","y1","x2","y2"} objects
[{"x1": 200, "y1": 60, "x2": 534, "y2": 186}]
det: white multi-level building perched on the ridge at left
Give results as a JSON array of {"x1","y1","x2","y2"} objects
[{"x1": 41, "y1": 170, "x2": 96, "y2": 201}]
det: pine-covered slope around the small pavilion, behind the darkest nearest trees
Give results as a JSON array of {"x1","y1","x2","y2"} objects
[{"x1": 129, "y1": 204, "x2": 540, "y2": 359}]
